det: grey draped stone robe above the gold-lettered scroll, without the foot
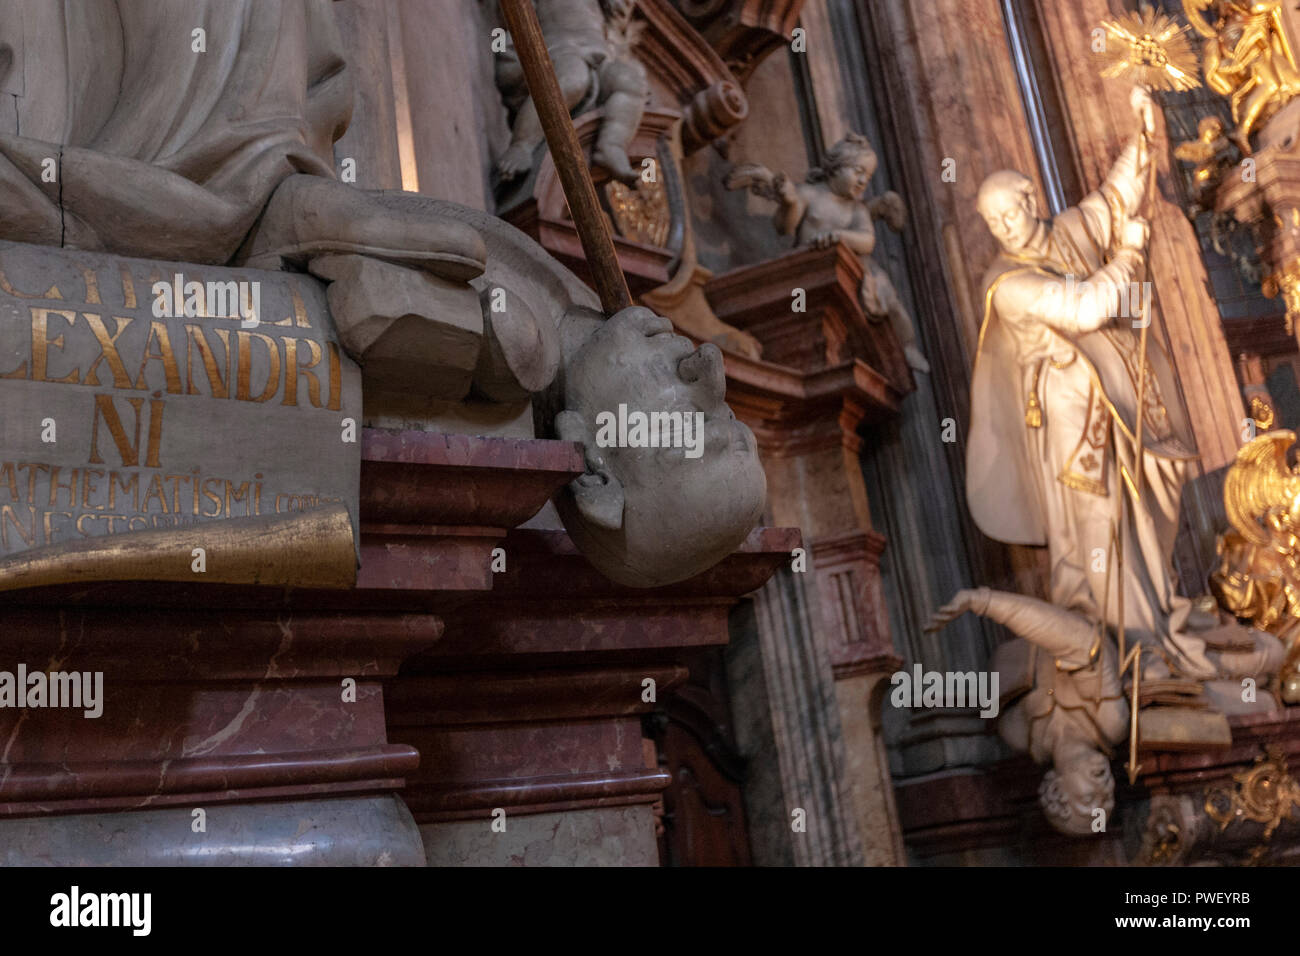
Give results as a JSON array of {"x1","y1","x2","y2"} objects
[{"x1": 0, "y1": 0, "x2": 352, "y2": 263}]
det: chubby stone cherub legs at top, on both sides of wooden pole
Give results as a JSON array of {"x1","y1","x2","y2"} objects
[{"x1": 497, "y1": 0, "x2": 650, "y2": 185}]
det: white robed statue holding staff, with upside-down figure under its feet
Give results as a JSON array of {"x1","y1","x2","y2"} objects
[{"x1": 930, "y1": 88, "x2": 1282, "y2": 835}]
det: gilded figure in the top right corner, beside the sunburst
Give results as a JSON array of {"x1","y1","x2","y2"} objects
[{"x1": 1183, "y1": 0, "x2": 1300, "y2": 155}]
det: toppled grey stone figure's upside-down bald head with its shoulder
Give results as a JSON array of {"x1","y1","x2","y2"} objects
[{"x1": 416, "y1": 198, "x2": 767, "y2": 587}]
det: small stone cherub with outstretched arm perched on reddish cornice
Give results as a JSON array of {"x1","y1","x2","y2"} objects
[{"x1": 725, "y1": 133, "x2": 930, "y2": 373}]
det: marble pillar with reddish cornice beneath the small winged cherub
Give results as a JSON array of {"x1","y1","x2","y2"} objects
[{"x1": 706, "y1": 246, "x2": 913, "y2": 865}]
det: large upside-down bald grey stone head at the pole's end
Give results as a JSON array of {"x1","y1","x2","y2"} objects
[{"x1": 555, "y1": 307, "x2": 767, "y2": 587}]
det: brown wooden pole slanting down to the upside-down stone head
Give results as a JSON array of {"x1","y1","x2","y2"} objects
[{"x1": 501, "y1": 0, "x2": 632, "y2": 316}]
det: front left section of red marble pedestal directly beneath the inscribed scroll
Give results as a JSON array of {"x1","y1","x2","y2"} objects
[{"x1": 0, "y1": 431, "x2": 581, "y2": 865}]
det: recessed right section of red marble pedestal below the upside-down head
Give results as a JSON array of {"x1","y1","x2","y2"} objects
[{"x1": 386, "y1": 528, "x2": 798, "y2": 866}]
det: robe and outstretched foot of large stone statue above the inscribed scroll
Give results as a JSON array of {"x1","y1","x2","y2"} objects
[{"x1": 0, "y1": 0, "x2": 485, "y2": 386}]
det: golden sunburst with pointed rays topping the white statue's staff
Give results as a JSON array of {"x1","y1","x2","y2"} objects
[{"x1": 1097, "y1": 7, "x2": 1201, "y2": 92}]
